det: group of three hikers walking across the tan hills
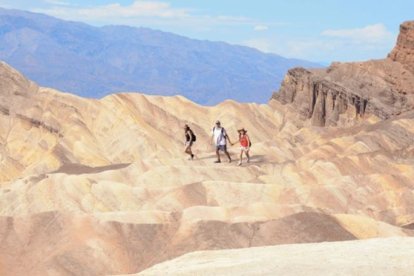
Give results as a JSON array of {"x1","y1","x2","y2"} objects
[{"x1": 184, "y1": 121, "x2": 251, "y2": 166}]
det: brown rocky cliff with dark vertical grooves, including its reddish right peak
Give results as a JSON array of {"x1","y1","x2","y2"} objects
[{"x1": 272, "y1": 22, "x2": 414, "y2": 126}]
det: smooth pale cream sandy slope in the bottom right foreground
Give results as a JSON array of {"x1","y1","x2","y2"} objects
[{"x1": 137, "y1": 238, "x2": 414, "y2": 276}]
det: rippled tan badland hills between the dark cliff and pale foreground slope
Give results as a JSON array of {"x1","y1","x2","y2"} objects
[{"x1": 0, "y1": 60, "x2": 414, "y2": 275}]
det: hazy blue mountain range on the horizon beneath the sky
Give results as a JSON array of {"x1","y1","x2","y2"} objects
[{"x1": 0, "y1": 8, "x2": 320, "y2": 104}]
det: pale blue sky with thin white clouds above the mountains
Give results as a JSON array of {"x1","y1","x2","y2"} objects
[{"x1": 0, "y1": 0, "x2": 414, "y2": 64}]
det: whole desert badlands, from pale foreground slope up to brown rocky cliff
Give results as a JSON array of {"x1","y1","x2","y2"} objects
[{"x1": 0, "y1": 22, "x2": 414, "y2": 275}]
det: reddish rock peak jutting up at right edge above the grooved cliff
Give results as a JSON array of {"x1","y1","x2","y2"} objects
[{"x1": 388, "y1": 21, "x2": 414, "y2": 72}]
